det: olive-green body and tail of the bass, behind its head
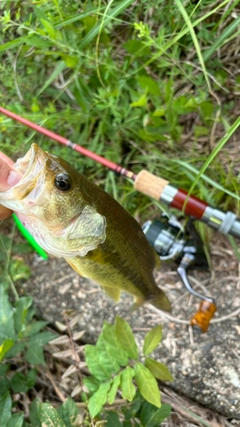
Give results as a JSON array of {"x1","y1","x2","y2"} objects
[{"x1": 68, "y1": 169, "x2": 170, "y2": 311}]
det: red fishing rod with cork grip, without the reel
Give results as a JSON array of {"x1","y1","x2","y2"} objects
[{"x1": 0, "y1": 107, "x2": 240, "y2": 238}]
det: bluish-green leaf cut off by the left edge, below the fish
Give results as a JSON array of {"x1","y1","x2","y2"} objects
[{"x1": 0, "y1": 286, "x2": 15, "y2": 344}]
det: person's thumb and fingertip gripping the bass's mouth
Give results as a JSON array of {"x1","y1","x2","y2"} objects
[{"x1": 0, "y1": 152, "x2": 21, "y2": 220}]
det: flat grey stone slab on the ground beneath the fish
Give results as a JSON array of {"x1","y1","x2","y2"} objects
[{"x1": 18, "y1": 242, "x2": 240, "y2": 425}]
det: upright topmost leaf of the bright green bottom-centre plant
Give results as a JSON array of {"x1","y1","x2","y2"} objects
[{"x1": 115, "y1": 316, "x2": 138, "y2": 359}]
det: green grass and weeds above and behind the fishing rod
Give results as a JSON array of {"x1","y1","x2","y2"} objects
[{"x1": 0, "y1": 0, "x2": 239, "y2": 213}]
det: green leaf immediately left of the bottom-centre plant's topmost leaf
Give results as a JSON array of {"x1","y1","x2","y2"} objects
[{"x1": 101, "y1": 322, "x2": 128, "y2": 366}]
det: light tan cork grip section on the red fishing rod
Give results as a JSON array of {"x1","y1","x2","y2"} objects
[{"x1": 134, "y1": 169, "x2": 169, "y2": 200}]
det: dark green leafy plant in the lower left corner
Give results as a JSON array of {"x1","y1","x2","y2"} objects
[{"x1": 0, "y1": 281, "x2": 56, "y2": 427}]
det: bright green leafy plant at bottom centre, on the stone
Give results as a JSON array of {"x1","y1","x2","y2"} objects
[{"x1": 84, "y1": 316, "x2": 173, "y2": 426}]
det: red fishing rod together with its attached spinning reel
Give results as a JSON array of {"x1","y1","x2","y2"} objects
[{"x1": 0, "y1": 107, "x2": 236, "y2": 332}]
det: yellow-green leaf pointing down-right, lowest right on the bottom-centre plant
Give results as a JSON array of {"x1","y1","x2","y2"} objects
[{"x1": 134, "y1": 362, "x2": 161, "y2": 408}]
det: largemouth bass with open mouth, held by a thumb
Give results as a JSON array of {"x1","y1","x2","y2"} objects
[{"x1": 0, "y1": 144, "x2": 170, "y2": 311}]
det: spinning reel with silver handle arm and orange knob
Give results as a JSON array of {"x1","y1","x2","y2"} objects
[{"x1": 142, "y1": 214, "x2": 216, "y2": 332}]
